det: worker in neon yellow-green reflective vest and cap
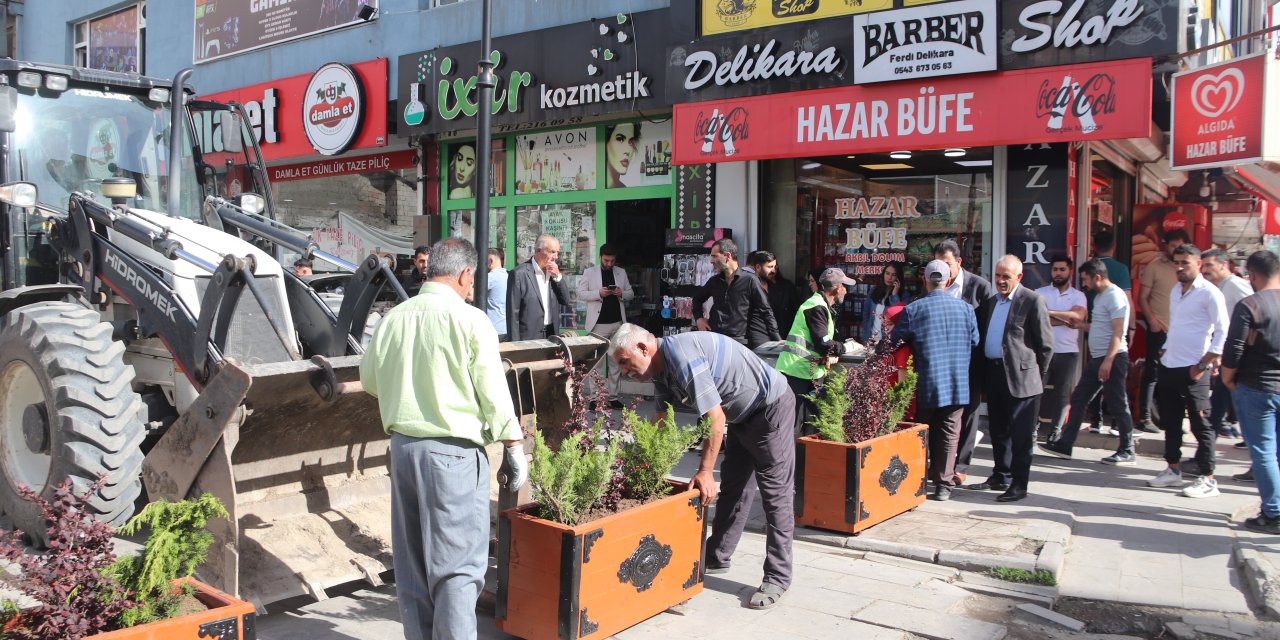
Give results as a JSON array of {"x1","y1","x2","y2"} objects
[{"x1": 777, "y1": 268, "x2": 858, "y2": 435}]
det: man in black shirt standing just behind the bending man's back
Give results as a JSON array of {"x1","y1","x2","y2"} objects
[{"x1": 694, "y1": 238, "x2": 782, "y2": 349}]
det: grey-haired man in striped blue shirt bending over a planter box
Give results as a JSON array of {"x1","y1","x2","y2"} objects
[{"x1": 609, "y1": 324, "x2": 796, "y2": 609}]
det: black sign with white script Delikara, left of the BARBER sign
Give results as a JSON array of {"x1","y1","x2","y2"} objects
[{"x1": 667, "y1": 20, "x2": 854, "y2": 101}]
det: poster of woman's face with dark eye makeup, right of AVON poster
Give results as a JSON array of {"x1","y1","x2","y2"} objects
[{"x1": 604, "y1": 120, "x2": 671, "y2": 189}]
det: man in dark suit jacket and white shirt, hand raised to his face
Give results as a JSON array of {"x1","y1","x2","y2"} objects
[{"x1": 507, "y1": 234, "x2": 572, "y2": 342}]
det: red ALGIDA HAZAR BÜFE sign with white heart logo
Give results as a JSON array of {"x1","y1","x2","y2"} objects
[{"x1": 1169, "y1": 54, "x2": 1280, "y2": 169}]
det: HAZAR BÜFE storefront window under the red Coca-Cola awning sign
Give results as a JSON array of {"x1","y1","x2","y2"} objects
[{"x1": 762, "y1": 148, "x2": 993, "y2": 337}]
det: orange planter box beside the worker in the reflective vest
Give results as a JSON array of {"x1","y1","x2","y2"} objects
[{"x1": 795, "y1": 422, "x2": 929, "y2": 534}]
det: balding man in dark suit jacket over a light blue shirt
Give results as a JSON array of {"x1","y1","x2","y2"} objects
[{"x1": 966, "y1": 256, "x2": 1053, "y2": 502}]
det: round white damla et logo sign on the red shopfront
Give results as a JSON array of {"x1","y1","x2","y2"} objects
[{"x1": 302, "y1": 63, "x2": 365, "y2": 156}]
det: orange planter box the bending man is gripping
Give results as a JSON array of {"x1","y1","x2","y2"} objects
[{"x1": 495, "y1": 484, "x2": 707, "y2": 640}]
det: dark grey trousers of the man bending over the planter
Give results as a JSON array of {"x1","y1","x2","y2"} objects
[{"x1": 707, "y1": 389, "x2": 796, "y2": 589}]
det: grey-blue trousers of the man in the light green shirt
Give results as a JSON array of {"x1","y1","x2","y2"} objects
[{"x1": 392, "y1": 433, "x2": 489, "y2": 640}]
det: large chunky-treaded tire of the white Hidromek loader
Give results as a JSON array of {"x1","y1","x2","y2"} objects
[{"x1": 0, "y1": 302, "x2": 146, "y2": 548}]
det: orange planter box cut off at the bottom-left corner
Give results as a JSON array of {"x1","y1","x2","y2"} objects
[{"x1": 86, "y1": 577, "x2": 257, "y2": 640}]
